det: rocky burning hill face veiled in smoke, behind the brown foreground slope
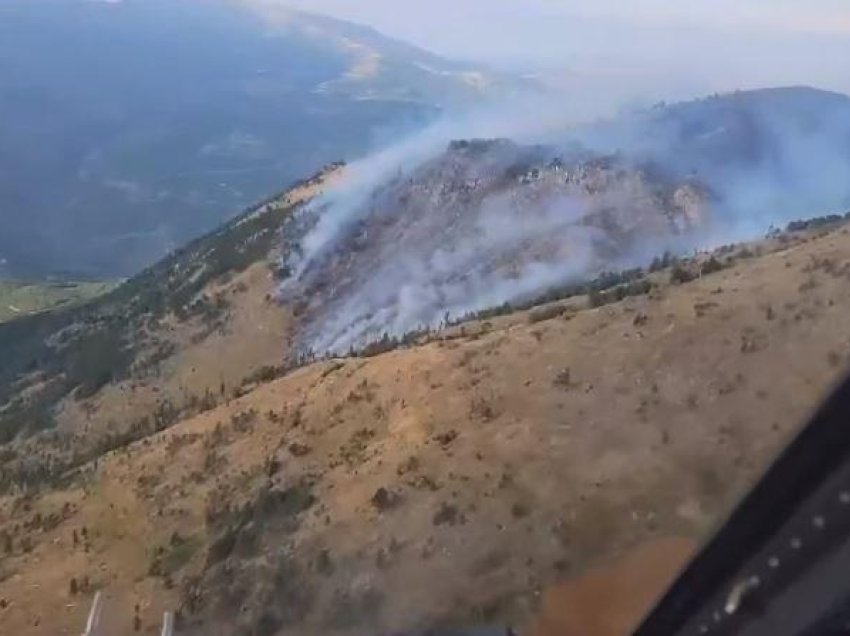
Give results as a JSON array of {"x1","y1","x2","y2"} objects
[{"x1": 284, "y1": 139, "x2": 710, "y2": 350}]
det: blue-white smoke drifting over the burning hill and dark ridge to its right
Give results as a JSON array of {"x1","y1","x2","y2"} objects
[{"x1": 281, "y1": 89, "x2": 850, "y2": 353}]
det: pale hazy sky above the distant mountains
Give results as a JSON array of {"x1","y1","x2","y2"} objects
[{"x1": 270, "y1": 0, "x2": 850, "y2": 97}]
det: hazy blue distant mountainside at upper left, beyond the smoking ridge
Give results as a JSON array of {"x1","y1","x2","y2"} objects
[{"x1": 0, "y1": 0, "x2": 529, "y2": 276}]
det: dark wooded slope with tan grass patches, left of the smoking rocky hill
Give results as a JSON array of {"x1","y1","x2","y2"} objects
[{"x1": 0, "y1": 165, "x2": 339, "y2": 472}]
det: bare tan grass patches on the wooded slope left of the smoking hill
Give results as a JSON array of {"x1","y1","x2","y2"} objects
[{"x1": 51, "y1": 166, "x2": 333, "y2": 438}]
